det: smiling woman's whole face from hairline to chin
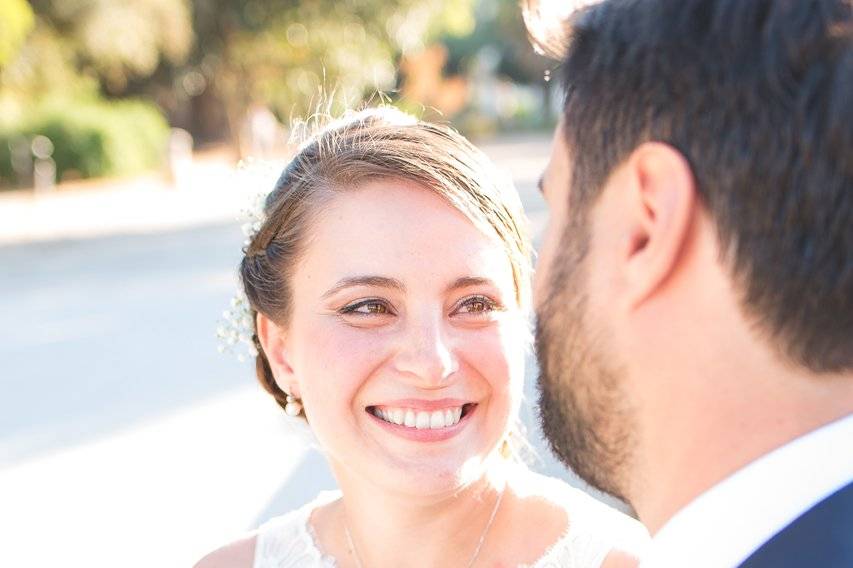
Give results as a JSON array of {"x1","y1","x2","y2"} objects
[{"x1": 279, "y1": 180, "x2": 526, "y2": 493}]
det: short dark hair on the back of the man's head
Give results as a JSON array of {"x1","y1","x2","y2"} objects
[{"x1": 540, "y1": 0, "x2": 853, "y2": 373}]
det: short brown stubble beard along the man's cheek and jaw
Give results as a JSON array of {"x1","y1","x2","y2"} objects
[{"x1": 536, "y1": 212, "x2": 635, "y2": 501}]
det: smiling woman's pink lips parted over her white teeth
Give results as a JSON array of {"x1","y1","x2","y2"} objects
[{"x1": 365, "y1": 399, "x2": 477, "y2": 442}]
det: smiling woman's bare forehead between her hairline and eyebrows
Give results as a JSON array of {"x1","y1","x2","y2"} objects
[{"x1": 294, "y1": 191, "x2": 512, "y2": 289}]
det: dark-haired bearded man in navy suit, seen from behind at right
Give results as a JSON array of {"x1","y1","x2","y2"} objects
[{"x1": 528, "y1": 0, "x2": 853, "y2": 568}]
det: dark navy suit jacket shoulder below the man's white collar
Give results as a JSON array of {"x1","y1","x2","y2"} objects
[{"x1": 740, "y1": 480, "x2": 853, "y2": 568}]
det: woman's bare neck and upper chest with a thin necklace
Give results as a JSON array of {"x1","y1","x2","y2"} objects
[{"x1": 326, "y1": 468, "x2": 504, "y2": 567}]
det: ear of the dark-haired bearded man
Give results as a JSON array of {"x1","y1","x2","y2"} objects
[{"x1": 608, "y1": 142, "x2": 698, "y2": 307}]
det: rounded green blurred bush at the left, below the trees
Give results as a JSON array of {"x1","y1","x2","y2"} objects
[{"x1": 0, "y1": 99, "x2": 169, "y2": 187}]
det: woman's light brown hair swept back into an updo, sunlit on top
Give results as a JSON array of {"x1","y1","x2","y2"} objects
[{"x1": 240, "y1": 108, "x2": 531, "y2": 418}]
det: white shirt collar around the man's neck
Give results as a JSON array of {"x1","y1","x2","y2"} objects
[{"x1": 640, "y1": 414, "x2": 853, "y2": 568}]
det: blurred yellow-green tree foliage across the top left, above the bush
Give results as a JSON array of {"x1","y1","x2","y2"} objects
[{"x1": 0, "y1": 0, "x2": 476, "y2": 155}]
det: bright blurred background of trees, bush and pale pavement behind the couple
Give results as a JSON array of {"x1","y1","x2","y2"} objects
[{"x1": 0, "y1": 0, "x2": 612, "y2": 567}]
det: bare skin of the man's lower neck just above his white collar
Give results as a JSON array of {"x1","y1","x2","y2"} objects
[{"x1": 632, "y1": 365, "x2": 853, "y2": 534}]
